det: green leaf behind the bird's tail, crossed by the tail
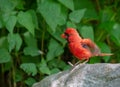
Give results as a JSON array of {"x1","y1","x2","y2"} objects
[{"x1": 97, "y1": 42, "x2": 111, "y2": 62}]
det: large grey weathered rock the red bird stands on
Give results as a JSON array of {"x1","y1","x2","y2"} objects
[{"x1": 33, "y1": 64, "x2": 120, "y2": 87}]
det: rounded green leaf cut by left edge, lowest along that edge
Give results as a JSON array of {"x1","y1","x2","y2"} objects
[{"x1": 0, "y1": 49, "x2": 11, "y2": 63}]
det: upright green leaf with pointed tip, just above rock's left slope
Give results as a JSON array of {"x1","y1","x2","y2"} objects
[{"x1": 38, "y1": 58, "x2": 51, "y2": 75}]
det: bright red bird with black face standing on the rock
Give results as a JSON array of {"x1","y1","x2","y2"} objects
[{"x1": 62, "y1": 28, "x2": 112, "y2": 61}]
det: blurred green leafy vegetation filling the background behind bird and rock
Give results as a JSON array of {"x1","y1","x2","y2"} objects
[{"x1": 0, "y1": 0, "x2": 120, "y2": 87}]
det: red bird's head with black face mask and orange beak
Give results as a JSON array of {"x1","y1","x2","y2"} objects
[{"x1": 61, "y1": 28, "x2": 79, "y2": 39}]
